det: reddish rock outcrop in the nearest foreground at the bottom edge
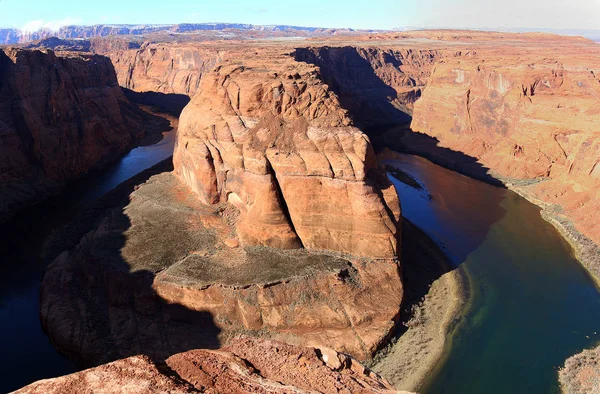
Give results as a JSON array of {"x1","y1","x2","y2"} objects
[{"x1": 15, "y1": 338, "x2": 408, "y2": 394}]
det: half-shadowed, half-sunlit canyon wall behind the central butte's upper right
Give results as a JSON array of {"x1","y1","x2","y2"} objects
[{"x1": 294, "y1": 46, "x2": 445, "y2": 126}]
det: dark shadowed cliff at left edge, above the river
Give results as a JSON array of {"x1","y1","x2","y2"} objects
[{"x1": 0, "y1": 49, "x2": 145, "y2": 221}]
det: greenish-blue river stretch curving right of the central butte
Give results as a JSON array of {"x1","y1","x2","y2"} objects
[{"x1": 384, "y1": 155, "x2": 600, "y2": 394}]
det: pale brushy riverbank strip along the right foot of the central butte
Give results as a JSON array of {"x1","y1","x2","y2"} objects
[{"x1": 369, "y1": 219, "x2": 470, "y2": 392}]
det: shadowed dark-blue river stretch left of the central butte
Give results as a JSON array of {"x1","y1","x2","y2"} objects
[{"x1": 0, "y1": 124, "x2": 175, "y2": 393}]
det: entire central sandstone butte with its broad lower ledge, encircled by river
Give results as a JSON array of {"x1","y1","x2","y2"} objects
[{"x1": 36, "y1": 43, "x2": 402, "y2": 365}]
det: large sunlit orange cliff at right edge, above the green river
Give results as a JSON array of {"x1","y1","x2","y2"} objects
[{"x1": 411, "y1": 38, "x2": 600, "y2": 246}]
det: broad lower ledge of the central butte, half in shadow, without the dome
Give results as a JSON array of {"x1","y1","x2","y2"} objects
[{"x1": 41, "y1": 173, "x2": 402, "y2": 365}]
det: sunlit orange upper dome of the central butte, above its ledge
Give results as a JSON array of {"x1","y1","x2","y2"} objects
[{"x1": 174, "y1": 53, "x2": 400, "y2": 258}]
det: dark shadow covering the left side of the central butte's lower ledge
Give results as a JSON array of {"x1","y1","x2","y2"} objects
[{"x1": 40, "y1": 160, "x2": 220, "y2": 367}]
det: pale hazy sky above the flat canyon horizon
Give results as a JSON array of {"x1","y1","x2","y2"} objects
[{"x1": 0, "y1": 0, "x2": 600, "y2": 30}]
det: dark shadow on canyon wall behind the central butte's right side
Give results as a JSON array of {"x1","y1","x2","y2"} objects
[{"x1": 293, "y1": 47, "x2": 503, "y2": 186}]
